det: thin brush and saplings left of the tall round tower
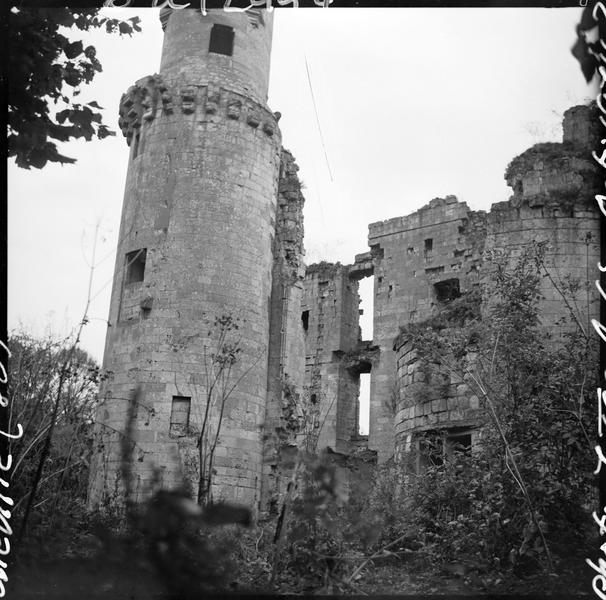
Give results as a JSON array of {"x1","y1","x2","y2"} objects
[{"x1": 9, "y1": 333, "x2": 101, "y2": 558}]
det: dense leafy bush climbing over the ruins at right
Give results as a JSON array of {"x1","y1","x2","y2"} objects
[{"x1": 368, "y1": 247, "x2": 597, "y2": 579}]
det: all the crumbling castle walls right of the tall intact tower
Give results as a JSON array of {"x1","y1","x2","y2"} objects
[{"x1": 292, "y1": 106, "x2": 599, "y2": 461}]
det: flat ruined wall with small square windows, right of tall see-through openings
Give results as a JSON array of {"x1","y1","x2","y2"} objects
[{"x1": 368, "y1": 196, "x2": 486, "y2": 460}]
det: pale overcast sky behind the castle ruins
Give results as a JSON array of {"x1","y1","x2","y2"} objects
[{"x1": 8, "y1": 7, "x2": 595, "y2": 370}]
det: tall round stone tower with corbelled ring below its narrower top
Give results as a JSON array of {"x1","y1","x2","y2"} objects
[{"x1": 89, "y1": 9, "x2": 281, "y2": 506}]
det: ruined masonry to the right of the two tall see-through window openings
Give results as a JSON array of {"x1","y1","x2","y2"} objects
[{"x1": 380, "y1": 107, "x2": 600, "y2": 461}]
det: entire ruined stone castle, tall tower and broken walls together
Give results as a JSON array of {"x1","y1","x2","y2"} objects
[{"x1": 89, "y1": 9, "x2": 599, "y2": 509}]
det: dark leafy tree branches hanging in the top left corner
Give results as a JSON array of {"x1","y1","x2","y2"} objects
[{"x1": 7, "y1": 8, "x2": 141, "y2": 169}]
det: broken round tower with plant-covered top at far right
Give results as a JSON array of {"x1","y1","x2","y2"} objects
[{"x1": 485, "y1": 104, "x2": 602, "y2": 330}]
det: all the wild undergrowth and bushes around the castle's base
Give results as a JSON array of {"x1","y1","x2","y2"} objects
[{"x1": 11, "y1": 246, "x2": 596, "y2": 597}]
